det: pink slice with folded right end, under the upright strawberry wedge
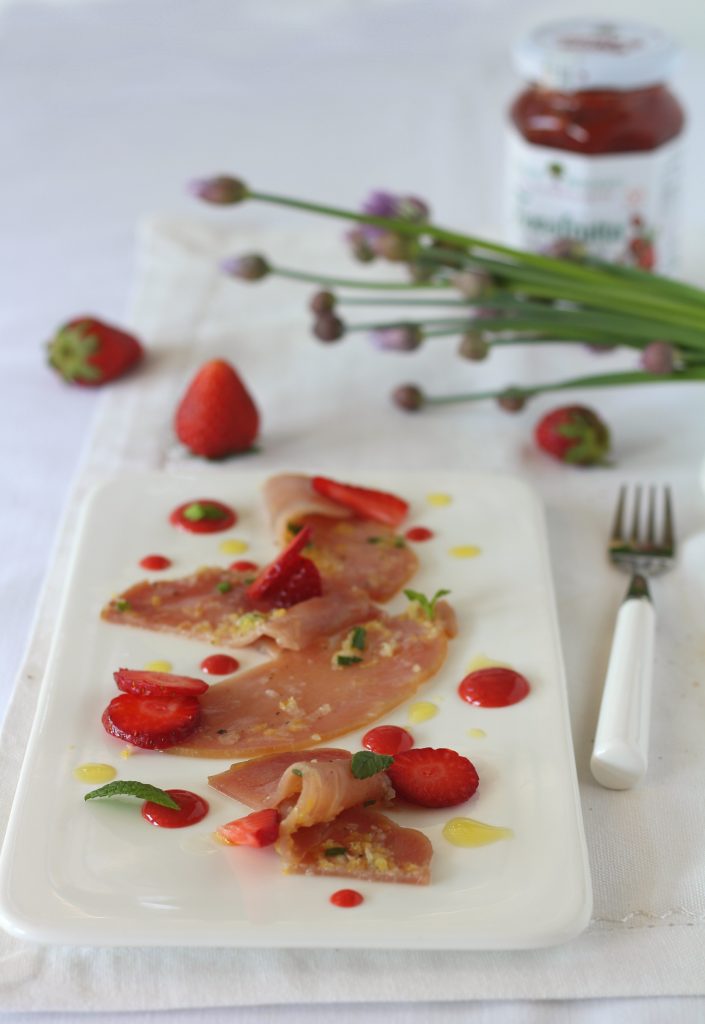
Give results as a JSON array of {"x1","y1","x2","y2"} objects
[{"x1": 101, "y1": 568, "x2": 375, "y2": 650}]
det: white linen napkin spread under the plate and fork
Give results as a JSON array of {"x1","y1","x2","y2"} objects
[{"x1": 0, "y1": 218, "x2": 705, "y2": 1011}]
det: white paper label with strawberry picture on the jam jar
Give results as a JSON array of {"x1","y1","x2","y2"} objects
[{"x1": 505, "y1": 129, "x2": 682, "y2": 273}]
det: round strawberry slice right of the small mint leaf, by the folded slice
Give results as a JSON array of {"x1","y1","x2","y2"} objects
[{"x1": 386, "y1": 746, "x2": 480, "y2": 807}]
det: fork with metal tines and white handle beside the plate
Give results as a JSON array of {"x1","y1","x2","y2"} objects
[{"x1": 590, "y1": 485, "x2": 675, "y2": 790}]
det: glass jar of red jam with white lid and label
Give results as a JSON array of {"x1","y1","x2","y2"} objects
[{"x1": 506, "y1": 18, "x2": 685, "y2": 273}]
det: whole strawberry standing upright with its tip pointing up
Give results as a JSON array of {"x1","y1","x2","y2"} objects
[{"x1": 174, "y1": 359, "x2": 259, "y2": 459}]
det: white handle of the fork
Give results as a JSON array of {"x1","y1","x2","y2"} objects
[{"x1": 590, "y1": 597, "x2": 656, "y2": 790}]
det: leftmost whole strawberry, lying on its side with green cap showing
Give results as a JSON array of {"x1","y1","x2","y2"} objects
[{"x1": 48, "y1": 316, "x2": 144, "y2": 387}]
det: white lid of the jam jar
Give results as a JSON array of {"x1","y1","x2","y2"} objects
[{"x1": 513, "y1": 17, "x2": 679, "y2": 91}]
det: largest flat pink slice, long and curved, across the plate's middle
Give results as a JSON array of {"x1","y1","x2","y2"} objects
[{"x1": 169, "y1": 602, "x2": 455, "y2": 758}]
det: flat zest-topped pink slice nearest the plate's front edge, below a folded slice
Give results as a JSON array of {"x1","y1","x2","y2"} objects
[{"x1": 280, "y1": 807, "x2": 433, "y2": 886}]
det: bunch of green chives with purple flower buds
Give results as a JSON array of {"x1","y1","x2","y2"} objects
[{"x1": 193, "y1": 176, "x2": 705, "y2": 410}]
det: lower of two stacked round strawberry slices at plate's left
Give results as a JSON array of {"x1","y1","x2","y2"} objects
[{"x1": 101, "y1": 693, "x2": 201, "y2": 751}]
